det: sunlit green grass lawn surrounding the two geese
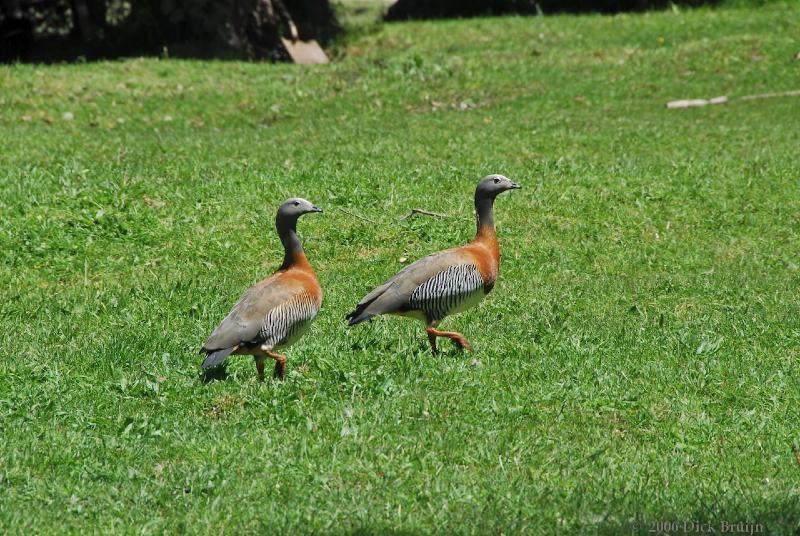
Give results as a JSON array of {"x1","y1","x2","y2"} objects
[{"x1": 0, "y1": 4, "x2": 800, "y2": 534}]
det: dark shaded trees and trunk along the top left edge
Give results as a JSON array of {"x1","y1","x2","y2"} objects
[{"x1": 0, "y1": 0, "x2": 340, "y2": 59}]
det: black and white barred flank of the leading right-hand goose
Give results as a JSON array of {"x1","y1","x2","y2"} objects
[{"x1": 411, "y1": 264, "x2": 484, "y2": 322}]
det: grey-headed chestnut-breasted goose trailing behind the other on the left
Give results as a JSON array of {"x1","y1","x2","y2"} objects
[{"x1": 200, "y1": 198, "x2": 322, "y2": 381}]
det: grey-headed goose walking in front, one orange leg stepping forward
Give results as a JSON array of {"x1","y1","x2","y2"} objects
[{"x1": 347, "y1": 175, "x2": 520, "y2": 355}]
